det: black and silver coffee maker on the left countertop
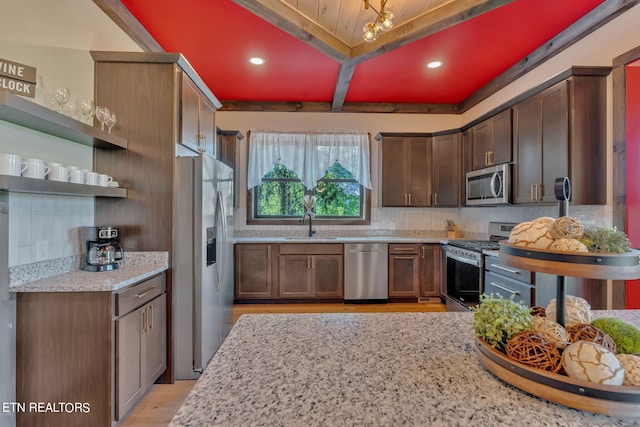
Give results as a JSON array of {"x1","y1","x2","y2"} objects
[{"x1": 80, "y1": 226, "x2": 124, "y2": 271}]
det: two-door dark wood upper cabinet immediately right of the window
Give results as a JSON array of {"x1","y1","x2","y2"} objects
[{"x1": 382, "y1": 136, "x2": 433, "y2": 207}]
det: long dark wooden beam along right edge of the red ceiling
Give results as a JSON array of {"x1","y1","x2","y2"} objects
[{"x1": 460, "y1": 0, "x2": 640, "y2": 113}]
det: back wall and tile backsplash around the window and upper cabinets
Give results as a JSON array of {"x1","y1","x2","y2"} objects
[{"x1": 216, "y1": 5, "x2": 640, "y2": 232}]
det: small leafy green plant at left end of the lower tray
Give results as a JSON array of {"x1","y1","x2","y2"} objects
[{"x1": 472, "y1": 294, "x2": 533, "y2": 352}]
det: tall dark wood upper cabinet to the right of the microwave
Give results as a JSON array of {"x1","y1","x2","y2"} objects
[{"x1": 512, "y1": 75, "x2": 606, "y2": 205}]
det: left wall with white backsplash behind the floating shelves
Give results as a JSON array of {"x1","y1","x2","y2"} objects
[{"x1": 0, "y1": 0, "x2": 140, "y2": 267}]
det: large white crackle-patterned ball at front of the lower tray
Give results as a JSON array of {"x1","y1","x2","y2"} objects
[{"x1": 562, "y1": 341, "x2": 624, "y2": 385}]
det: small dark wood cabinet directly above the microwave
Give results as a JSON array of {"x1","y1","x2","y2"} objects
[{"x1": 471, "y1": 109, "x2": 512, "y2": 170}]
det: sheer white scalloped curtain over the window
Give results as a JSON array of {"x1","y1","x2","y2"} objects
[{"x1": 247, "y1": 130, "x2": 371, "y2": 189}]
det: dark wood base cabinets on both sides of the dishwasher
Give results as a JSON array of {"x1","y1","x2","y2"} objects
[{"x1": 235, "y1": 243, "x2": 442, "y2": 302}]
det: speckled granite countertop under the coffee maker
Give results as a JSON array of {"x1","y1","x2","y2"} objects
[{"x1": 9, "y1": 252, "x2": 169, "y2": 292}]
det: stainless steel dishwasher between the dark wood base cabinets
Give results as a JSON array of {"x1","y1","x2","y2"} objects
[{"x1": 344, "y1": 243, "x2": 389, "y2": 303}]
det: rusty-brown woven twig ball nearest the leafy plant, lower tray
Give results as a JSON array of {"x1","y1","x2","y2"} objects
[{"x1": 506, "y1": 331, "x2": 562, "y2": 373}]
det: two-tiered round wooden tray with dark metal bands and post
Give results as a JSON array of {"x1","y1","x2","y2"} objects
[{"x1": 475, "y1": 242, "x2": 640, "y2": 417}]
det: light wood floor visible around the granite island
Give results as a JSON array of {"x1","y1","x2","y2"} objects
[{"x1": 121, "y1": 302, "x2": 446, "y2": 427}]
